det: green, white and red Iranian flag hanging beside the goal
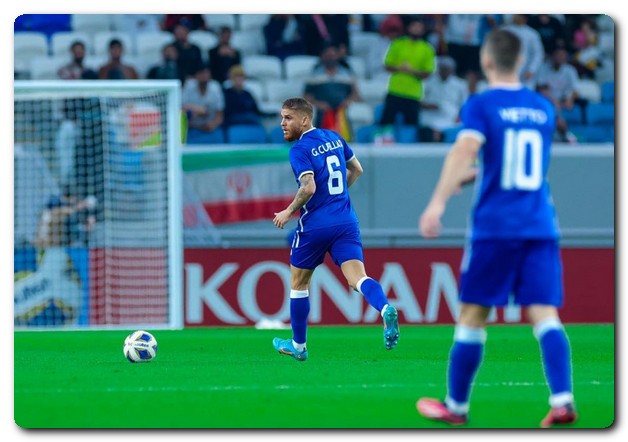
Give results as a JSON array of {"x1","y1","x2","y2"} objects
[{"x1": 182, "y1": 146, "x2": 297, "y2": 224}]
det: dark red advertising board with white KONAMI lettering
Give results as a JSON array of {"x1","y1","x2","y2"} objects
[{"x1": 184, "y1": 248, "x2": 615, "y2": 327}]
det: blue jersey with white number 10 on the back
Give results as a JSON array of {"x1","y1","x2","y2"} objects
[{"x1": 459, "y1": 86, "x2": 558, "y2": 239}]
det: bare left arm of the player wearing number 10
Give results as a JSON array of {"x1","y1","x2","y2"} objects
[{"x1": 419, "y1": 136, "x2": 482, "y2": 238}]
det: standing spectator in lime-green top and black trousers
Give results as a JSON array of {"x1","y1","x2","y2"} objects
[{"x1": 379, "y1": 18, "x2": 436, "y2": 137}]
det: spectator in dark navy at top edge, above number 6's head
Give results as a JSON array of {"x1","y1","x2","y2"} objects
[{"x1": 264, "y1": 14, "x2": 305, "y2": 61}]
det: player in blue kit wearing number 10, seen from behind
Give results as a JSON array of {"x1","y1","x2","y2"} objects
[{"x1": 416, "y1": 29, "x2": 577, "y2": 427}]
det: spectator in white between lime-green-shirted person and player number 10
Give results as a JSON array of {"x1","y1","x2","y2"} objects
[{"x1": 419, "y1": 56, "x2": 468, "y2": 142}]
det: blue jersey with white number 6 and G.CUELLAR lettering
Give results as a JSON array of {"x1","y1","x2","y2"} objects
[{"x1": 290, "y1": 128, "x2": 358, "y2": 232}]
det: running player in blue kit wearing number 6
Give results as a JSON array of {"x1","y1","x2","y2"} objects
[{"x1": 273, "y1": 98, "x2": 399, "y2": 361}]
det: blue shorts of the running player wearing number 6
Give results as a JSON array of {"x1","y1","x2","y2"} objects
[{"x1": 290, "y1": 223, "x2": 364, "y2": 270}]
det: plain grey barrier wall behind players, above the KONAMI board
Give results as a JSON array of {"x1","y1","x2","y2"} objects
[{"x1": 195, "y1": 144, "x2": 615, "y2": 247}]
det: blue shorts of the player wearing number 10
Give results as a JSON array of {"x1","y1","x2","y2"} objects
[{"x1": 460, "y1": 240, "x2": 563, "y2": 307}]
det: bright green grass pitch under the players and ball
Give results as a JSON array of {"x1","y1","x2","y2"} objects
[{"x1": 14, "y1": 325, "x2": 615, "y2": 429}]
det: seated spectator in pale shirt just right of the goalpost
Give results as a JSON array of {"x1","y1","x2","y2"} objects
[{"x1": 181, "y1": 64, "x2": 225, "y2": 144}]
